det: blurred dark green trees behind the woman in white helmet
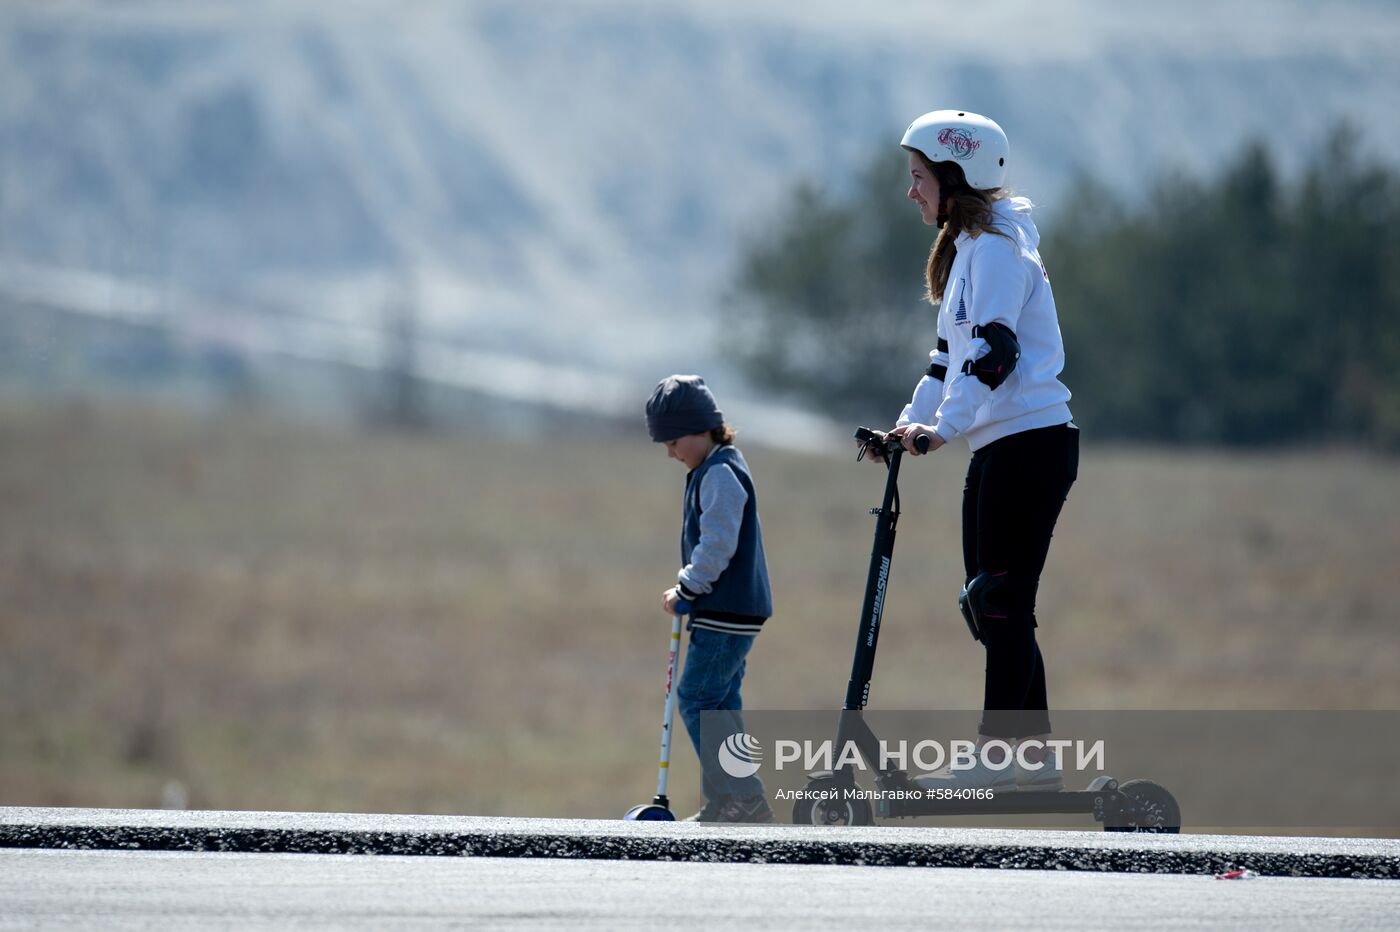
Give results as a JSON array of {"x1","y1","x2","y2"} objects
[{"x1": 724, "y1": 125, "x2": 1400, "y2": 451}]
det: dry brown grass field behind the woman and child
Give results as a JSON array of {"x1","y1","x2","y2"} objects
[{"x1": 0, "y1": 394, "x2": 1400, "y2": 817}]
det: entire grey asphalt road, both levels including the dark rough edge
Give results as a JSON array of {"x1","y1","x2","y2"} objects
[{"x1": 0, "y1": 807, "x2": 1400, "y2": 931}]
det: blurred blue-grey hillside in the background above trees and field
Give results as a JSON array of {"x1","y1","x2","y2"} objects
[{"x1": 0, "y1": 0, "x2": 1400, "y2": 428}]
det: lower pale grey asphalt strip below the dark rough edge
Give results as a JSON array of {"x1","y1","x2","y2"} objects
[{"x1": 0, "y1": 849, "x2": 1400, "y2": 932}]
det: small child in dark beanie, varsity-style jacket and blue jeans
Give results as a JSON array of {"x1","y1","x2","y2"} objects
[{"x1": 647, "y1": 375, "x2": 773, "y2": 821}]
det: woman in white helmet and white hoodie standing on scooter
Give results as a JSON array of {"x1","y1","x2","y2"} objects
[{"x1": 892, "y1": 111, "x2": 1079, "y2": 791}]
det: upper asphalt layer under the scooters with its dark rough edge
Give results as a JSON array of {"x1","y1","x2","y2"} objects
[{"x1": 0, "y1": 807, "x2": 1400, "y2": 880}]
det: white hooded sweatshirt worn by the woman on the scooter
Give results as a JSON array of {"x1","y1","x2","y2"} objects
[{"x1": 896, "y1": 197, "x2": 1071, "y2": 451}]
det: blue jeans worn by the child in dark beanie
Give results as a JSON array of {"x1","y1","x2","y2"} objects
[{"x1": 676, "y1": 628, "x2": 763, "y2": 800}]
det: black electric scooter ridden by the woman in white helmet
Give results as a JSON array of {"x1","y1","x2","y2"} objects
[{"x1": 792, "y1": 427, "x2": 1182, "y2": 833}]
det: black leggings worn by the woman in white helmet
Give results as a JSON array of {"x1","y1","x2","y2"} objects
[{"x1": 963, "y1": 424, "x2": 1079, "y2": 739}]
